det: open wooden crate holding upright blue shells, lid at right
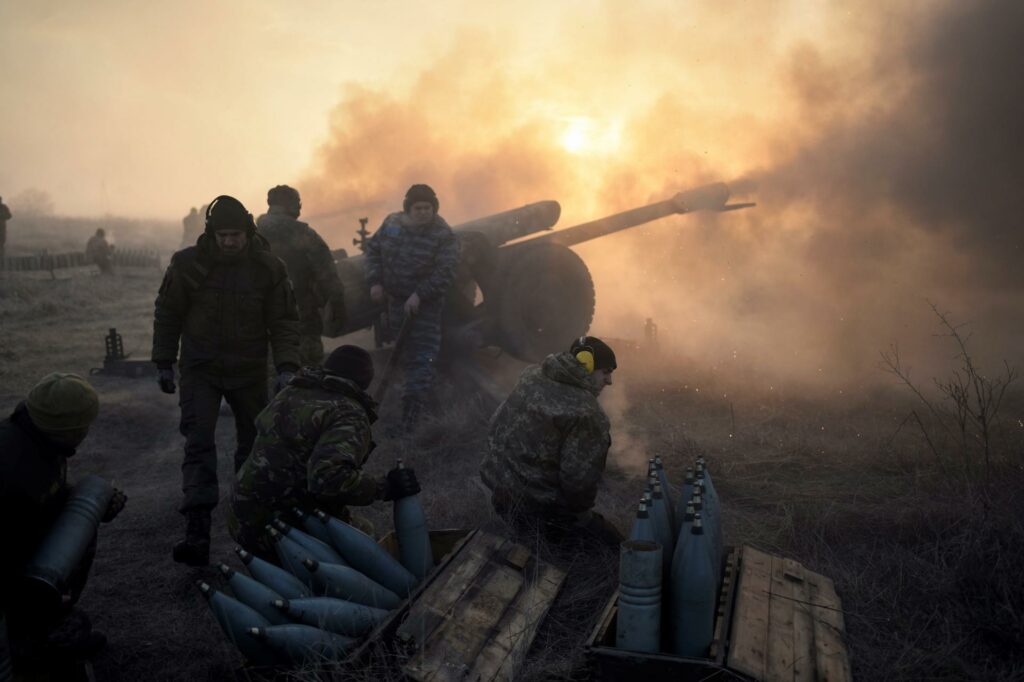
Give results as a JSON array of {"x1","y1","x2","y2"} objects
[{"x1": 588, "y1": 546, "x2": 852, "y2": 682}]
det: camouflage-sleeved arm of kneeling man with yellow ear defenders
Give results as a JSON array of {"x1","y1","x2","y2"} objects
[{"x1": 559, "y1": 417, "x2": 611, "y2": 513}]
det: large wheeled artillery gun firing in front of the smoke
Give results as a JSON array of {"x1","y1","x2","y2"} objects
[{"x1": 325, "y1": 182, "x2": 754, "y2": 361}]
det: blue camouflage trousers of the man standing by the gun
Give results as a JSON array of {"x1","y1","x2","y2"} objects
[{"x1": 388, "y1": 299, "x2": 443, "y2": 406}]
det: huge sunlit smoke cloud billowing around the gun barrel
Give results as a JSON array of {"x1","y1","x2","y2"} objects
[{"x1": 302, "y1": 0, "x2": 1024, "y2": 384}]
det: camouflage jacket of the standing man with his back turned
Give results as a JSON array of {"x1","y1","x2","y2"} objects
[{"x1": 256, "y1": 206, "x2": 344, "y2": 335}]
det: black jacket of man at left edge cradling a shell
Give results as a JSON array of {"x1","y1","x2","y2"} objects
[{"x1": 0, "y1": 402, "x2": 75, "y2": 610}]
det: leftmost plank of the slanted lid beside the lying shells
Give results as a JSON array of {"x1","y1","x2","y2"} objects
[{"x1": 402, "y1": 561, "x2": 523, "y2": 682}]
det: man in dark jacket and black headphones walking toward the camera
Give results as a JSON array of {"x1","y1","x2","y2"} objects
[{"x1": 153, "y1": 197, "x2": 299, "y2": 566}]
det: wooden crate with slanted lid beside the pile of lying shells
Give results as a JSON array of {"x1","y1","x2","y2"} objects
[{"x1": 352, "y1": 530, "x2": 565, "y2": 682}]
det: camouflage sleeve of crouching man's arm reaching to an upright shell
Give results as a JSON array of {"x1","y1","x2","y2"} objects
[{"x1": 306, "y1": 411, "x2": 380, "y2": 511}]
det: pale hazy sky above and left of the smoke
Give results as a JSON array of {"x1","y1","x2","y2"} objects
[{"x1": 0, "y1": 0, "x2": 821, "y2": 217}]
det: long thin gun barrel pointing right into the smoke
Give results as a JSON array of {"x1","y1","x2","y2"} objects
[{"x1": 527, "y1": 182, "x2": 729, "y2": 246}]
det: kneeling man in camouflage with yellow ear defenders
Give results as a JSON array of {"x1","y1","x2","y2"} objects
[{"x1": 480, "y1": 336, "x2": 624, "y2": 546}]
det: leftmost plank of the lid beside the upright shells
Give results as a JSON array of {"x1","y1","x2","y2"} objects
[{"x1": 727, "y1": 546, "x2": 771, "y2": 680}]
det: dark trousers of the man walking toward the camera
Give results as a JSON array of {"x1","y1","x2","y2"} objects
[{"x1": 178, "y1": 373, "x2": 267, "y2": 514}]
